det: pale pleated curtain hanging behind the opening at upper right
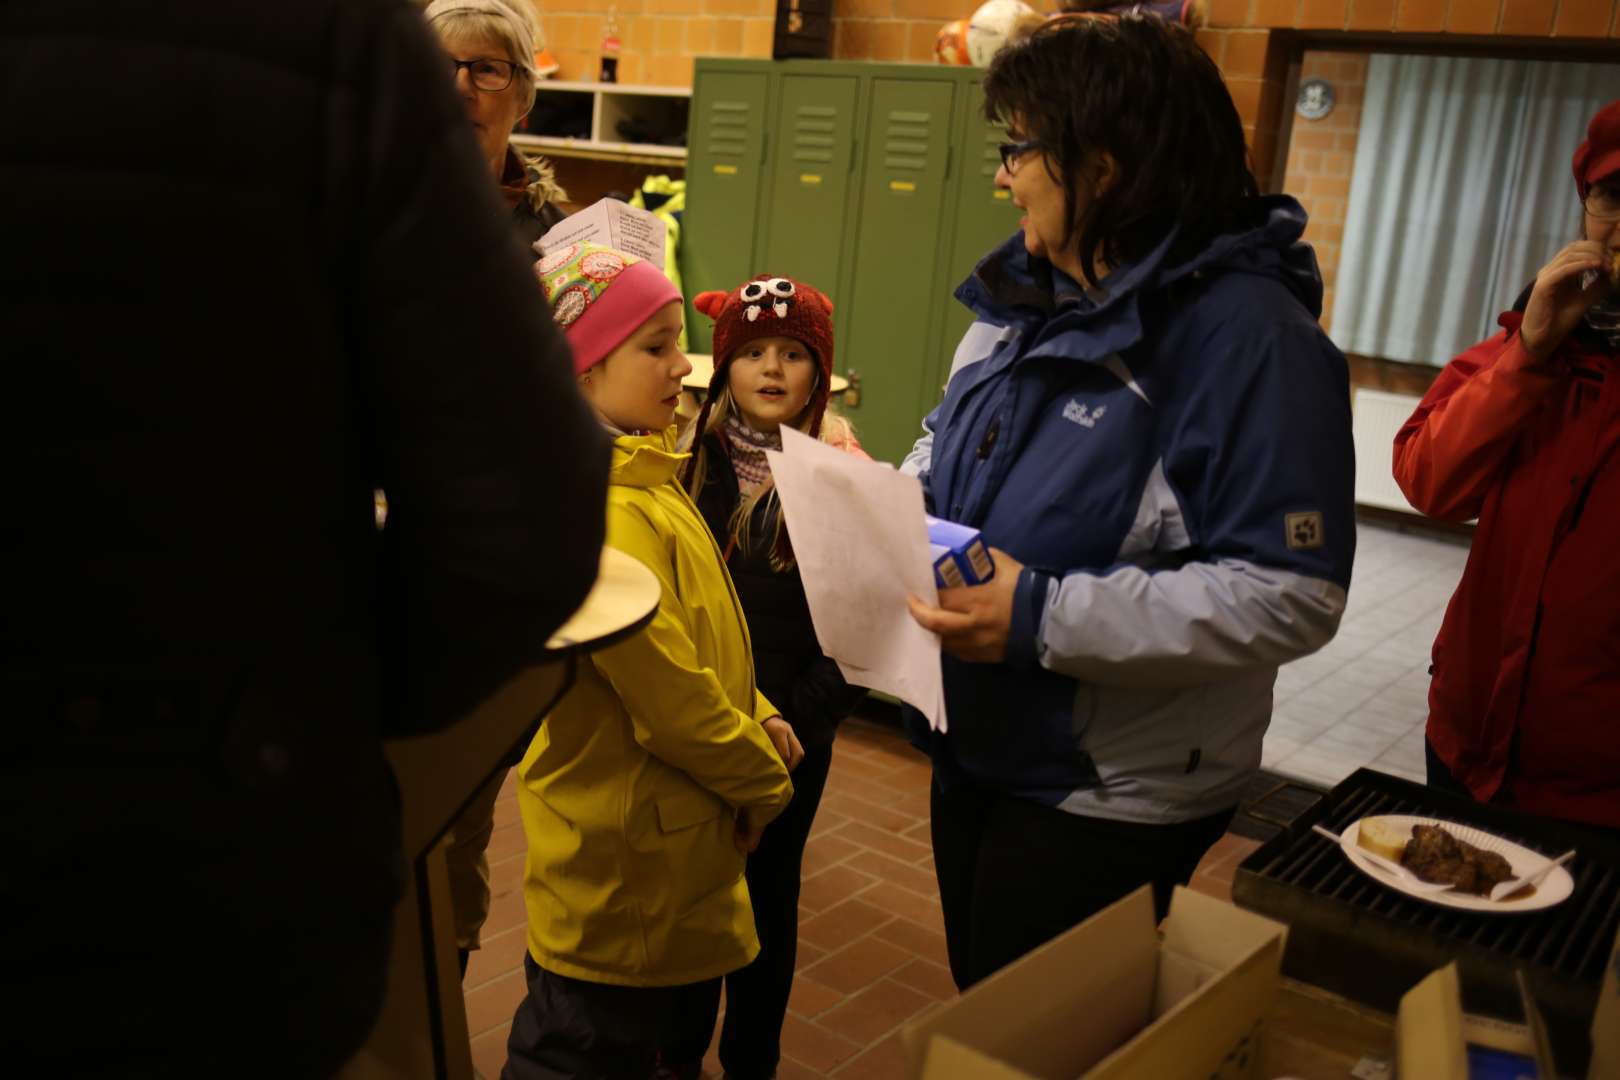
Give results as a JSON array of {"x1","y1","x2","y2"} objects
[{"x1": 1332, "y1": 55, "x2": 1620, "y2": 366}]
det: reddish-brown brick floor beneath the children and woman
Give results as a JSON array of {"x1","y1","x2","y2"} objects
[{"x1": 463, "y1": 719, "x2": 1257, "y2": 1080}]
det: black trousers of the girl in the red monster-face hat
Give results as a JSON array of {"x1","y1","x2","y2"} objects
[{"x1": 716, "y1": 745, "x2": 833, "y2": 1080}]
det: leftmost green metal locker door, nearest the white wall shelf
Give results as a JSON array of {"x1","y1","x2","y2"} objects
[{"x1": 680, "y1": 62, "x2": 771, "y2": 353}]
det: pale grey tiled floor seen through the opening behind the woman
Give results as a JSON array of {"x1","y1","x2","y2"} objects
[{"x1": 1264, "y1": 521, "x2": 1468, "y2": 787}]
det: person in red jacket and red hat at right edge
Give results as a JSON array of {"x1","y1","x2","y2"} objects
[{"x1": 1395, "y1": 100, "x2": 1620, "y2": 829}]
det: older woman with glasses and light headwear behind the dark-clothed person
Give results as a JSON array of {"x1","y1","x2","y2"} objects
[{"x1": 426, "y1": 0, "x2": 569, "y2": 250}]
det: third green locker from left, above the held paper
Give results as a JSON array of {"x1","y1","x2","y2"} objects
[{"x1": 839, "y1": 78, "x2": 956, "y2": 461}]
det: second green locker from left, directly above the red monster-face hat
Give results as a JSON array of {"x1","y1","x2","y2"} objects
[{"x1": 755, "y1": 73, "x2": 860, "y2": 325}]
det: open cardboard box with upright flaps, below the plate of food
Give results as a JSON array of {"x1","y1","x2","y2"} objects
[{"x1": 1395, "y1": 963, "x2": 1558, "y2": 1080}]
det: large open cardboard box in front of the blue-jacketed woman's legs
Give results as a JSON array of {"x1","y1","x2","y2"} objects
[{"x1": 901, "y1": 887, "x2": 1288, "y2": 1080}]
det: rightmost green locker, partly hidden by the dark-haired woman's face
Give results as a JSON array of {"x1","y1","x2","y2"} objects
[{"x1": 928, "y1": 78, "x2": 1021, "y2": 395}]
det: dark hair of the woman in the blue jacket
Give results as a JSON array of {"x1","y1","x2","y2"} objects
[{"x1": 985, "y1": 15, "x2": 1259, "y2": 285}]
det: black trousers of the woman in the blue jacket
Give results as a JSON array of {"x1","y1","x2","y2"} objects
[{"x1": 932, "y1": 779, "x2": 1236, "y2": 989}]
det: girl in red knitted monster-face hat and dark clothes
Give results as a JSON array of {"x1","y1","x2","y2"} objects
[{"x1": 685, "y1": 274, "x2": 867, "y2": 1080}]
